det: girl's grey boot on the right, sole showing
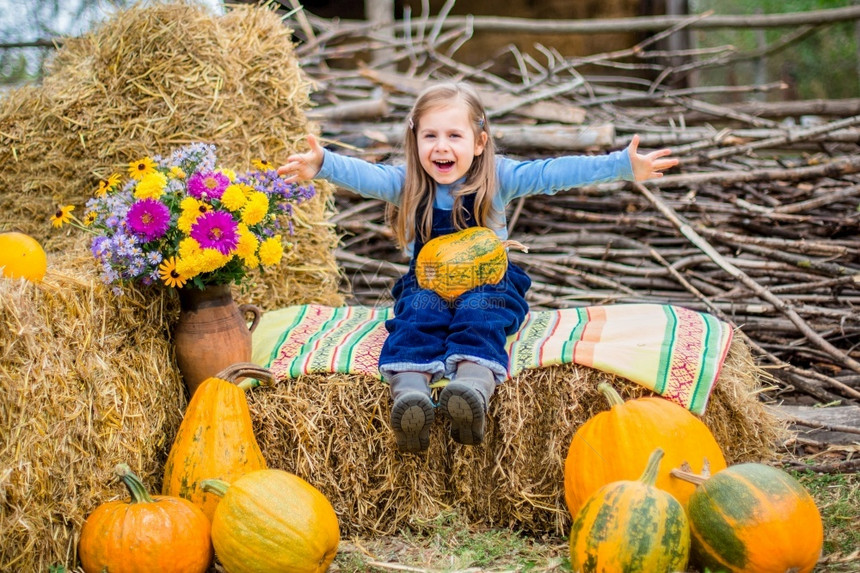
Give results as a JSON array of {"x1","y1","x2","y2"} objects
[{"x1": 439, "y1": 360, "x2": 496, "y2": 445}]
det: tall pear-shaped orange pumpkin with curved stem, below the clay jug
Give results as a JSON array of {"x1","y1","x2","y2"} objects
[{"x1": 161, "y1": 362, "x2": 273, "y2": 519}]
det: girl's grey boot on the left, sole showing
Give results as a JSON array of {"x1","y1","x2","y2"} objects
[{"x1": 389, "y1": 372, "x2": 434, "y2": 452}]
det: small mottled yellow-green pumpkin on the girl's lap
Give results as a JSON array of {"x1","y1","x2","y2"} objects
[{"x1": 415, "y1": 227, "x2": 527, "y2": 302}]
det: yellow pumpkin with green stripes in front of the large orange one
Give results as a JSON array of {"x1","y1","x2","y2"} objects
[{"x1": 570, "y1": 448, "x2": 690, "y2": 573}]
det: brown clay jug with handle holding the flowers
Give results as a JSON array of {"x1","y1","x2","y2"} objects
[{"x1": 173, "y1": 285, "x2": 262, "y2": 399}]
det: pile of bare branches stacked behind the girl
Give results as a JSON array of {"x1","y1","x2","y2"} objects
[{"x1": 284, "y1": 3, "x2": 860, "y2": 404}]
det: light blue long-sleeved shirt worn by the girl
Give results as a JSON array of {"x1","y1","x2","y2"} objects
[{"x1": 317, "y1": 149, "x2": 634, "y2": 256}]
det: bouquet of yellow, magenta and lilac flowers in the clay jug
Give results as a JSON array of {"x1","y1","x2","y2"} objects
[{"x1": 51, "y1": 143, "x2": 315, "y2": 292}]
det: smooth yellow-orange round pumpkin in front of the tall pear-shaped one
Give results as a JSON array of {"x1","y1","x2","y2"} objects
[{"x1": 203, "y1": 470, "x2": 340, "y2": 573}]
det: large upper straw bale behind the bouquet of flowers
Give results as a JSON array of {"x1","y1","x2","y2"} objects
[{"x1": 0, "y1": 2, "x2": 343, "y2": 308}]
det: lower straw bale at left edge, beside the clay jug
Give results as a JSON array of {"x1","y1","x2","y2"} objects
[{"x1": 0, "y1": 252, "x2": 185, "y2": 571}]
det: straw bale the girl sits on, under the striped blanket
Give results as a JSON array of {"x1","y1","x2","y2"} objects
[{"x1": 250, "y1": 337, "x2": 781, "y2": 535}]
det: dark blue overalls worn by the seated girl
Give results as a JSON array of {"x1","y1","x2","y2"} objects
[{"x1": 379, "y1": 194, "x2": 531, "y2": 384}]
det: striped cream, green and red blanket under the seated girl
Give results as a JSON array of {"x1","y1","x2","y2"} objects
[{"x1": 253, "y1": 304, "x2": 732, "y2": 414}]
